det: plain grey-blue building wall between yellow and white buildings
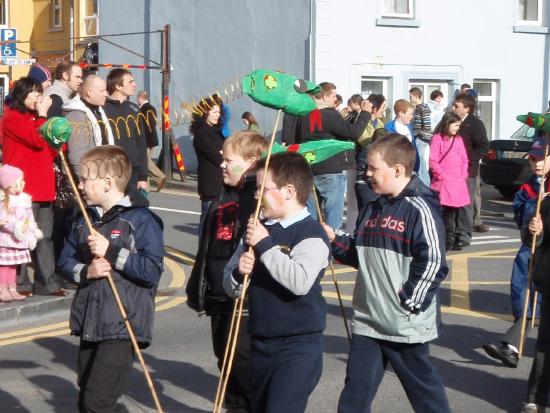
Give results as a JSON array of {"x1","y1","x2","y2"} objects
[{"x1": 99, "y1": 0, "x2": 310, "y2": 170}]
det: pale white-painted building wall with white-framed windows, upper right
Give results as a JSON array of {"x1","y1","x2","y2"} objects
[{"x1": 315, "y1": 0, "x2": 550, "y2": 138}]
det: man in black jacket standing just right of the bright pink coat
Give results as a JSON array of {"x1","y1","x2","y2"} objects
[{"x1": 453, "y1": 93, "x2": 489, "y2": 247}]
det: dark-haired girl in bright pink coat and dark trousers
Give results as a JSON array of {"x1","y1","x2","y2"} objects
[{"x1": 430, "y1": 113, "x2": 470, "y2": 251}]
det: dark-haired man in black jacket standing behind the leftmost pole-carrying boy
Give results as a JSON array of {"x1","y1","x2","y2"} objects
[{"x1": 103, "y1": 69, "x2": 149, "y2": 206}]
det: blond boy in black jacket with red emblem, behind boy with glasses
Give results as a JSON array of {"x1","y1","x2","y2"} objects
[{"x1": 185, "y1": 131, "x2": 269, "y2": 413}]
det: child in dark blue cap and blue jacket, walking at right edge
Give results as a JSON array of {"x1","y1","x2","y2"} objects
[{"x1": 483, "y1": 137, "x2": 550, "y2": 367}]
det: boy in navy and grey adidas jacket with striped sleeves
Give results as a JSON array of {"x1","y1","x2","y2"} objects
[{"x1": 325, "y1": 134, "x2": 450, "y2": 413}]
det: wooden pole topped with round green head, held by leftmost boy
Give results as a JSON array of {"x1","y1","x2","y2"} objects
[{"x1": 40, "y1": 117, "x2": 163, "y2": 413}]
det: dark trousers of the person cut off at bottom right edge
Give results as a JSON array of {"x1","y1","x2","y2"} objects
[{"x1": 527, "y1": 293, "x2": 550, "y2": 407}]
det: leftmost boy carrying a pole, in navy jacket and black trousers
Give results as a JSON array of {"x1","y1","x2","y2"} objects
[{"x1": 58, "y1": 145, "x2": 164, "y2": 412}]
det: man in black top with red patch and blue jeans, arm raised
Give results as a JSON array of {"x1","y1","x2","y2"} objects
[{"x1": 297, "y1": 82, "x2": 372, "y2": 229}]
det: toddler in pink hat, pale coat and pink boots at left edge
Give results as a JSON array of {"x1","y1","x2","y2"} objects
[{"x1": 0, "y1": 165, "x2": 42, "y2": 303}]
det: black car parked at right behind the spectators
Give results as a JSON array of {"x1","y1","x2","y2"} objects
[{"x1": 480, "y1": 125, "x2": 537, "y2": 198}]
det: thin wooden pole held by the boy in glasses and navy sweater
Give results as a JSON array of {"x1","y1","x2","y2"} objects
[{"x1": 213, "y1": 109, "x2": 282, "y2": 413}]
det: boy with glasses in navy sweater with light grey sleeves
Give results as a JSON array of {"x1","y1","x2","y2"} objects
[{"x1": 224, "y1": 153, "x2": 329, "y2": 413}]
